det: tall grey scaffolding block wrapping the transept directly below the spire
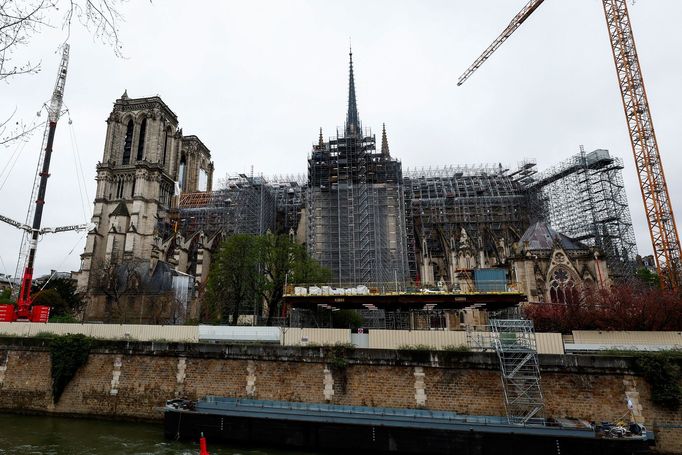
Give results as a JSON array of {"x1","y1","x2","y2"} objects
[{"x1": 306, "y1": 128, "x2": 407, "y2": 286}]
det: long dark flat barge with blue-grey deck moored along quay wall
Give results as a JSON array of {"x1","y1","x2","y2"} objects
[{"x1": 164, "y1": 396, "x2": 653, "y2": 455}]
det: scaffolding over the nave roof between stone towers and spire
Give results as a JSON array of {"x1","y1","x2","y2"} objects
[{"x1": 177, "y1": 174, "x2": 275, "y2": 236}]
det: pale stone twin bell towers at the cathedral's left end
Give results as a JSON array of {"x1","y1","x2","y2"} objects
[{"x1": 75, "y1": 92, "x2": 213, "y2": 319}]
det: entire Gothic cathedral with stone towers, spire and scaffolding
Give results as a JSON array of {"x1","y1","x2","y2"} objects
[{"x1": 69, "y1": 53, "x2": 636, "y2": 323}]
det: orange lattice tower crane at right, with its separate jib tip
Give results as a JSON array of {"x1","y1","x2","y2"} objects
[{"x1": 457, "y1": 0, "x2": 681, "y2": 290}]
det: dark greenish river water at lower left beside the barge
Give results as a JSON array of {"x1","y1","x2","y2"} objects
[{"x1": 0, "y1": 414, "x2": 310, "y2": 455}]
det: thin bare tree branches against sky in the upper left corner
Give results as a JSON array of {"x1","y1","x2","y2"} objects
[{"x1": 0, "y1": 0, "x2": 125, "y2": 145}]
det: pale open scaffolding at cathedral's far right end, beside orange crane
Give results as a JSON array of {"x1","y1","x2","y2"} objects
[{"x1": 529, "y1": 146, "x2": 637, "y2": 279}]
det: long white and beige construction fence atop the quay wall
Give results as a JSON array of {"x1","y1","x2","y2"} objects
[{"x1": 0, "y1": 322, "x2": 682, "y2": 354}]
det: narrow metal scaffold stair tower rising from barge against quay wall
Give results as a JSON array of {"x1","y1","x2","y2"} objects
[{"x1": 490, "y1": 319, "x2": 544, "y2": 425}]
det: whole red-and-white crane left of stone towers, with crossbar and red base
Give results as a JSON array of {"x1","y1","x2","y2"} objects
[{"x1": 0, "y1": 44, "x2": 75, "y2": 322}]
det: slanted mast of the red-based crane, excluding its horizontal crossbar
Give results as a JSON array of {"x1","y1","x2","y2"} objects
[{"x1": 16, "y1": 44, "x2": 69, "y2": 322}]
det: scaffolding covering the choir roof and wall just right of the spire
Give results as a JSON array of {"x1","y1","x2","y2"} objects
[{"x1": 403, "y1": 161, "x2": 535, "y2": 284}]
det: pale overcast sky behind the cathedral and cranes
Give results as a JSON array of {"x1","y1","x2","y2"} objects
[{"x1": 0, "y1": 0, "x2": 682, "y2": 274}]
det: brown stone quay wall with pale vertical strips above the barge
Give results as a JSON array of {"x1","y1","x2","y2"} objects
[{"x1": 0, "y1": 338, "x2": 682, "y2": 453}]
